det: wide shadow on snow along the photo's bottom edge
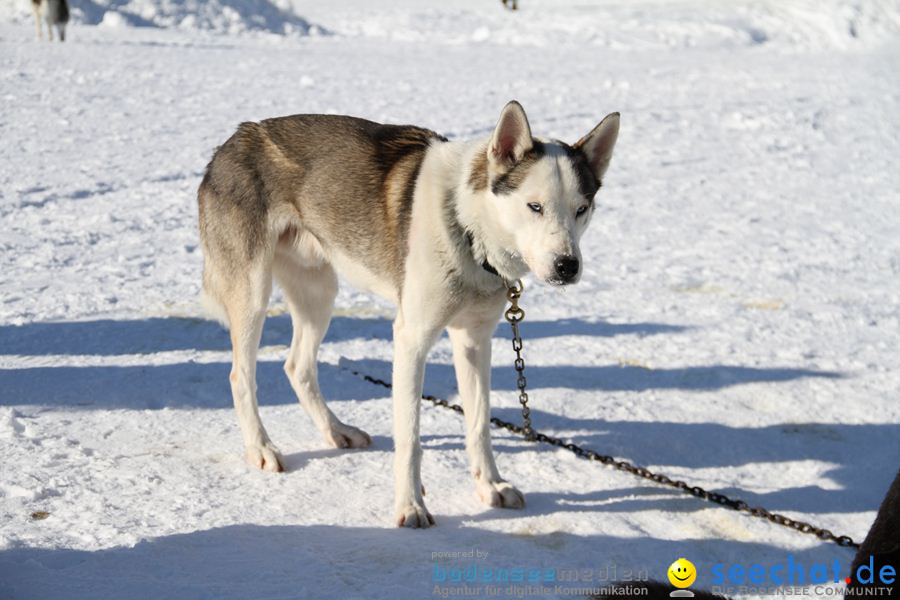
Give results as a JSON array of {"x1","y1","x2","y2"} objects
[{"x1": 0, "y1": 511, "x2": 852, "y2": 600}]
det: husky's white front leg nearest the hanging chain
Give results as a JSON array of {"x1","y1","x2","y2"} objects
[{"x1": 447, "y1": 295, "x2": 525, "y2": 508}]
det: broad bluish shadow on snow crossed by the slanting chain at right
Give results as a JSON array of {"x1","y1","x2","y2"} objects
[{"x1": 422, "y1": 410, "x2": 900, "y2": 519}]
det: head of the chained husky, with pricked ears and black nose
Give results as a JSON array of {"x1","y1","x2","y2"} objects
[{"x1": 471, "y1": 101, "x2": 619, "y2": 285}]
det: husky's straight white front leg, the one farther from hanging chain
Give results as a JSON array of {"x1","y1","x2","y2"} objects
[{"x1": 393, "y1": 310, "x2": 440, "y2": 528}]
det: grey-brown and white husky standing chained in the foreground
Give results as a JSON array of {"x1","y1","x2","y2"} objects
[{"x1": 198, "y1": 101, "x2": 619, "y2": 527}]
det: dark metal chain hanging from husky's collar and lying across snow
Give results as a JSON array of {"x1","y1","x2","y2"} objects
[{"x1": 342, "y1": 281, "x2": 859, "y2": 548}]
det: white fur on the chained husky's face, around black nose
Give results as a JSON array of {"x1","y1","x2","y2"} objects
[{"x1": 492, "y1": 143, "x2": 593, "y2": 285}]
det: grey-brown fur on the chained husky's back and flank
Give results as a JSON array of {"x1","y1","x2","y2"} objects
[{"x1": 199, "y1": 115, "x2": 444, "y2": 285}]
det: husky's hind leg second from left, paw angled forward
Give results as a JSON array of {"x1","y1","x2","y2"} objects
[{"x1": 274, "y1": 251, "x2": 372, "y2": 448}]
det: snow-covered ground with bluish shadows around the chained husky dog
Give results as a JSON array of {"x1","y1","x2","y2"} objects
[{"x1": 0, "y1": 0, "x2": 900, "y2": 599}]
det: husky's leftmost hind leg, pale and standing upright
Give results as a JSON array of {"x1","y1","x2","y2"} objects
[{"x1": 223, "y1": 256, "x2": 284, "y2": 472}]
